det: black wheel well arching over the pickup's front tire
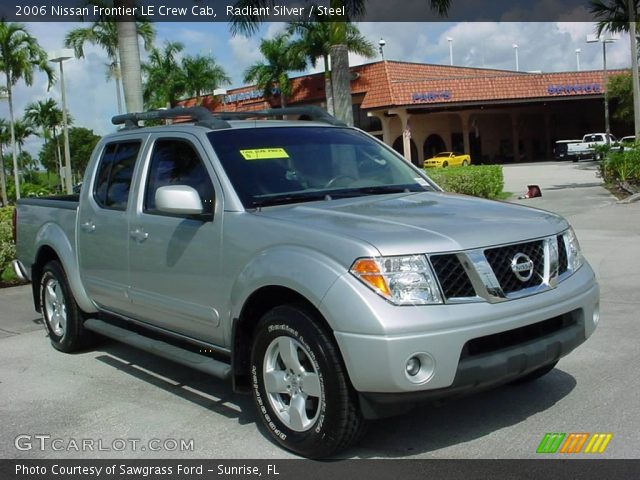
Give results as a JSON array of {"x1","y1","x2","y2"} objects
[{"x1": 231, "y1": 286, "x2": 333, "y2": 393}]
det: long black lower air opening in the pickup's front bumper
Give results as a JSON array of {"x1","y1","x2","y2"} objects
[{"x1": 462, "y1": 313, "x2": 576, "y2": 358}]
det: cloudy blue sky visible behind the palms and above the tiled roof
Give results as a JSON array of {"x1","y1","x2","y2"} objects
[{"x1": 0, "y1": 22, "x2": 630, "y2": 153}]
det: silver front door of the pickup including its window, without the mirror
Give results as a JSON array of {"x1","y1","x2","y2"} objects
[{"x1": 129, "y1": 133, "x2": 223, "y2": 344}]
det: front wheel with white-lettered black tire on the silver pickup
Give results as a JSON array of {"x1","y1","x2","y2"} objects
[{"x1": 251, "y1": 305, "x2": 364, "y2": 458}]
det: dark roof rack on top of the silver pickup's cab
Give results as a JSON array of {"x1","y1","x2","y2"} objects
[{"x1": 111, "y1": 106, "x2": 345, "y2": 130}]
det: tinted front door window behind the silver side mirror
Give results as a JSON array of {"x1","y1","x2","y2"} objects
[{"x1": 144, "y1": 139, "x2": 214, "y2": 213}]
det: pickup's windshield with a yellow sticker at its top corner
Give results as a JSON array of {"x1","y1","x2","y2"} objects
[{"x1": 208, "y1": 127, "x2": 434, "y2": 208}]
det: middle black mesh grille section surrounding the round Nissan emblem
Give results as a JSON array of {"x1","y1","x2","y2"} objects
[{"x1": 484, "y1": 240, "x2": 544, "y2": 294}]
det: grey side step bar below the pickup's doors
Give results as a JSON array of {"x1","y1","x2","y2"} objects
[{"x1": 84, "y1": 318, "x2": 231, "y2": 380}]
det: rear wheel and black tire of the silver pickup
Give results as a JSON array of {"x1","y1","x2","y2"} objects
[{"x1": 40, "y1": 260, "x2": 95, "y2": 353}]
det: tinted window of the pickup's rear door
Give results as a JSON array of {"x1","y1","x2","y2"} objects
[{"x1": 93, "y1": 142, "x2": 140, "y2": 210}]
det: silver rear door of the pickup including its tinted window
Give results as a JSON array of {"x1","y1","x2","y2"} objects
[{"x1": 76, "y1": 136, "x2": 143, "y2": 314}]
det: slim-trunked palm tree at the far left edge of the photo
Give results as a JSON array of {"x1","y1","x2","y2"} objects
[{"x1": 0, "y1": 20, "x2": 54, "y2": 200}]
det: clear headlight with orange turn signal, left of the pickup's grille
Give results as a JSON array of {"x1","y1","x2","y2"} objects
[{"x1": 349, "y1": 255, "x2": 442, "y2": 305}]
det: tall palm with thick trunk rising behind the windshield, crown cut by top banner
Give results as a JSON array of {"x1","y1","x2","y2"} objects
[{"x1": 231, "y1": 0, "x2": 451, "y2": 125}]
